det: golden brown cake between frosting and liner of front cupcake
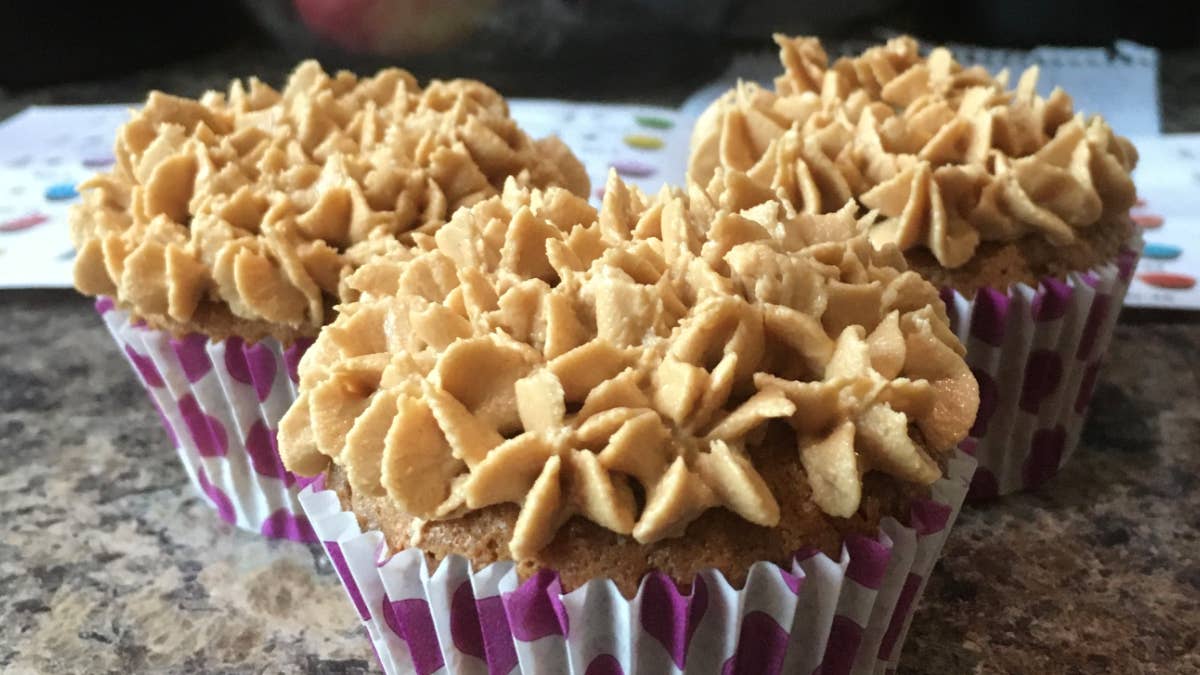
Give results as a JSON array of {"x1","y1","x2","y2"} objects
[{"x1": 326, "y1": 444, "x2": 928, "y2": 597}]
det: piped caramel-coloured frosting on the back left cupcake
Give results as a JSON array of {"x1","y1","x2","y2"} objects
[{"x1": 71, "y1": 61, "x2": 588, "y2": 333}]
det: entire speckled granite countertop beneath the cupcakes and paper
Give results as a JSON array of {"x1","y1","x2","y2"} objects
[{"x1": 0, "y1": 42, "x2": 1200, "y2": 675}]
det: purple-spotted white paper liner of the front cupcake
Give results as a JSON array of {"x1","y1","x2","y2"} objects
[{"x1": 300, "y1": 453, "x2": 976, "y2": 675}]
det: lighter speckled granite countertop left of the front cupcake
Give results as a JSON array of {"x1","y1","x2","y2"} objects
[{"x1": 0, "y1": 291, "x2": 372, "y2": 673}]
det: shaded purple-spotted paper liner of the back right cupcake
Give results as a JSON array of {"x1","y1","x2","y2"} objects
[{"x1": 942, "y1": 235, "x2": 1142, "y2": 501}]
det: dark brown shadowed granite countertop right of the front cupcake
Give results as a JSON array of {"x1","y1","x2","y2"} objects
[{"x1": 901, "y1": 313, "x2": 1200, "y2": 674}]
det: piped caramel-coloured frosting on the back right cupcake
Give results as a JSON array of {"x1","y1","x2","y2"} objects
[{"x1": 689, "y1": 35, "x2": 1138, "y2": 268}]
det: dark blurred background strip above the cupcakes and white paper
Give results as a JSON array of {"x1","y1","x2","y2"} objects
[{"x1": 0, "y1": 0, "x2": 1200, "y2": 97}]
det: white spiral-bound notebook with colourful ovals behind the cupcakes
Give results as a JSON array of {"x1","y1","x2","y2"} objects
[{"x1": 0, "y1": 42, "x2": 1200, "y2": 309}]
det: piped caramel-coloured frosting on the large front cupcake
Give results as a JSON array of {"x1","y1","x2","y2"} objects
[{"x1": 280, "y1": 172, "x2": 978, "y2": 560}]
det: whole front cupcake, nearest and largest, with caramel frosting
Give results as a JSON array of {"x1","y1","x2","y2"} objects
[{"x1": 280, "y1": 171, "x2": 978, "y2": 673}]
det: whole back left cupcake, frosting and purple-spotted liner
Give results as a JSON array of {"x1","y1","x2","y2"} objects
[{"x1": 70, "y1": 61, "x2": 588, "y2": 539}]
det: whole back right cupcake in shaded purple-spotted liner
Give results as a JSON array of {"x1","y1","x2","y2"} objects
[{"x1": 689, "y1": 36, "x2": 1141, "y2": 498}]
